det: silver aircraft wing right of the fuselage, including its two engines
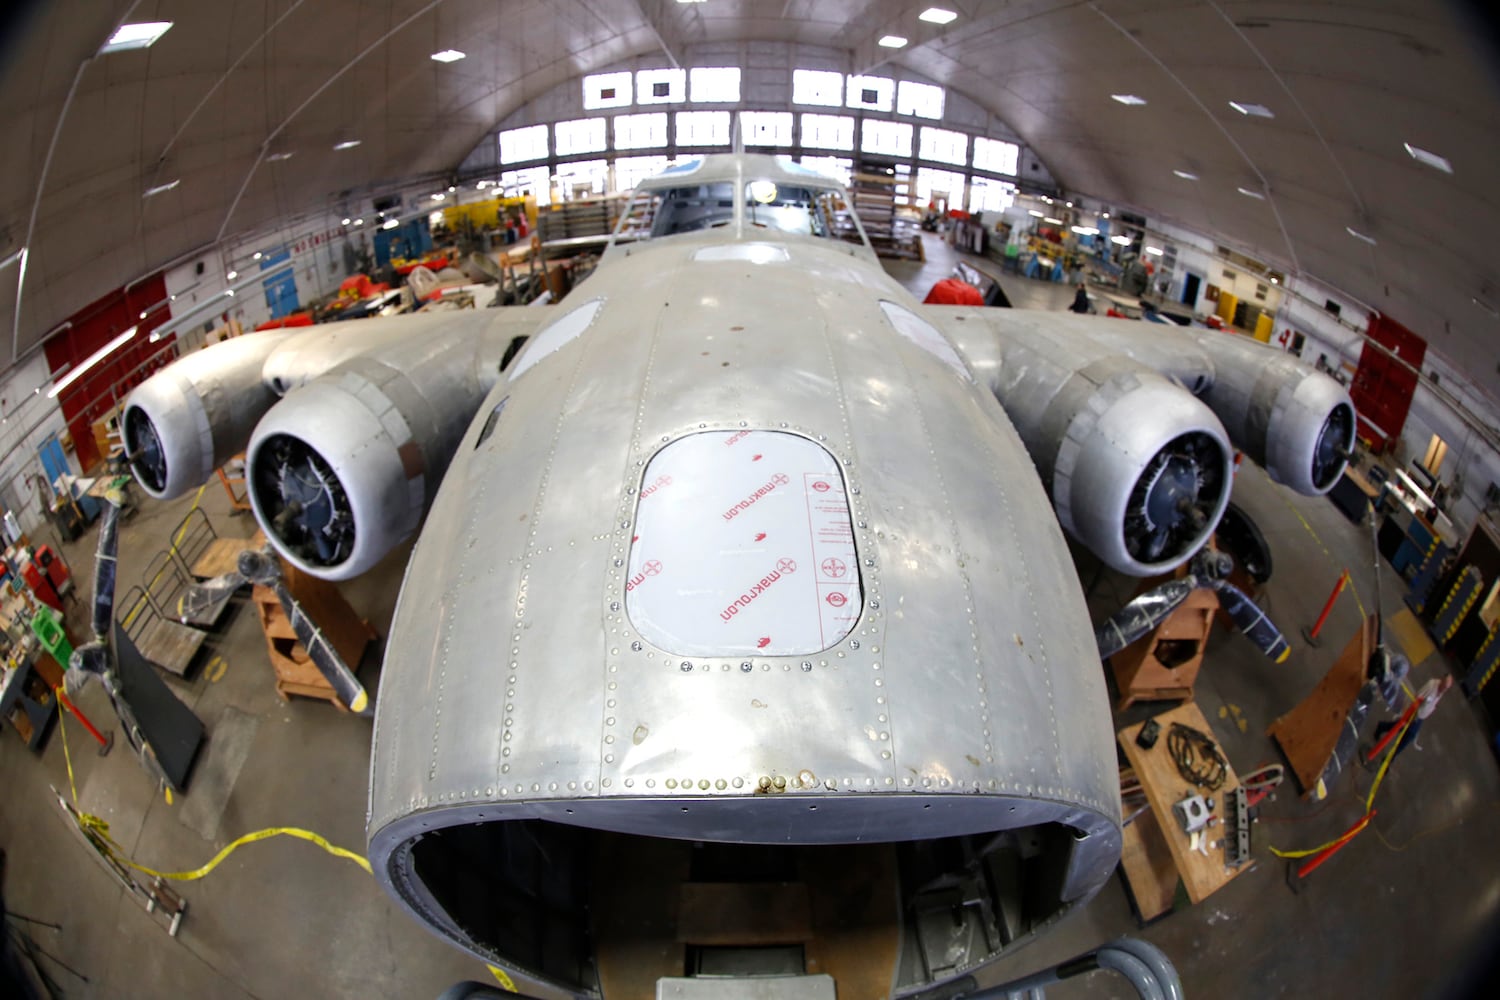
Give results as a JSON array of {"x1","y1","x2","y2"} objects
[{"x1": 923, "y1": 306, "x2": 1355, "y2": 576}]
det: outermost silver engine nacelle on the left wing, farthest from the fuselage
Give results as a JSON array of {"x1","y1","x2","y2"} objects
[{"x1": 120, "y1": 330, "x2": 293, "y2": 499}]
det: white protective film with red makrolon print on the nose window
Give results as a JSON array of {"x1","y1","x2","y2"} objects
[{"x1": 626, "y1": 430, "x2": 864, "y2": 657}]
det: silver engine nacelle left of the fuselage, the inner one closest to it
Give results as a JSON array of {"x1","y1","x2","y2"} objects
[{"x1": 246, "y1": 355, "x2": 483, "y2": 580}]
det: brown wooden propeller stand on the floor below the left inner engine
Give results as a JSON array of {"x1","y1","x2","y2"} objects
[{"x1": 254, "y1": 562, "x2": 377, "y2": 712}]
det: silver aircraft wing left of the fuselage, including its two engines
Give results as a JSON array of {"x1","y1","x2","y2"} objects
[{"x1": 123, "y1": 306, "x2": 557, "y2": 579}]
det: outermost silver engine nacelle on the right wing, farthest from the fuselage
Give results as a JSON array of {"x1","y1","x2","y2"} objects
[{"x1": 1197, "y1": 333, "x2": 1355, "y2": 495}]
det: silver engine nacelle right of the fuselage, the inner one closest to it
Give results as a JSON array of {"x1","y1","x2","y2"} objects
[{"x1": 999, "y1": 354, "x2": 1232, "y2": 576}]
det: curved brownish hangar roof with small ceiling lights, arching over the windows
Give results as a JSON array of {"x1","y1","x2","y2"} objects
[{"x1": 0, "y1": 0, "x2": 1500, "y2": 391}]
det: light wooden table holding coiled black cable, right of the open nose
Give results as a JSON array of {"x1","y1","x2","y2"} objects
[{"x1": 1118, "y1": 702, "x2": 1251, "y2": 921}]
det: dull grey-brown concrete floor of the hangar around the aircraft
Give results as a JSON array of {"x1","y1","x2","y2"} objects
[{"x1": 0, "y1": 237, "x2": 1500, "y2": 1000}]
